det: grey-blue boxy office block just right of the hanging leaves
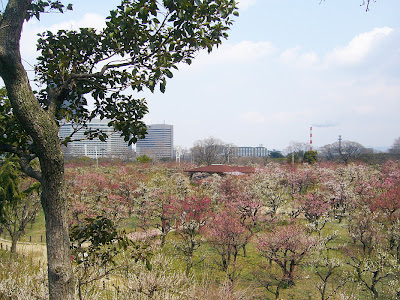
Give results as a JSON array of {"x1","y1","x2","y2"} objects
[{"x1": 136, "y1": 124, "x2": 174, "y2": 159}]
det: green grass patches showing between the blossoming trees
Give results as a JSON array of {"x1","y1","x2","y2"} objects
[{"x1": 4, "y1": 212, "x2": 396, "y2": 300}]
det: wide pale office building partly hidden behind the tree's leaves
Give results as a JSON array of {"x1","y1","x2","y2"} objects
[{"x1": 59, "y1": 119, "x2": 131, "y2": 159}]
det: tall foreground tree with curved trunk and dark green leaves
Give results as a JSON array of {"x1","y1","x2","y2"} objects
[{"x1": 0, "y1": 0, "x2": 236, "y2": 299}]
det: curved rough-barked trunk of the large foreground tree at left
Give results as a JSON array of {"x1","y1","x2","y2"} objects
[{"x1": 0, "y1": 0, "x2": 74, "y2": 299}]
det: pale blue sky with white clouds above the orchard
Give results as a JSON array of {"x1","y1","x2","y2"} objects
[{"x1": 10, "y1": 0, "x2": 400, "y2": 150}]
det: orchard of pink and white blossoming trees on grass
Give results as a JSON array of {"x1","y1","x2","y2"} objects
[{"x1": 0, "y1": 161, "x2": 400, "y2": 299}]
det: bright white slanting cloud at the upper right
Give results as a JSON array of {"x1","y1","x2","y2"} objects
[{"x1": 326, "y1": 27, "x2": 394, "y2": 65}]
